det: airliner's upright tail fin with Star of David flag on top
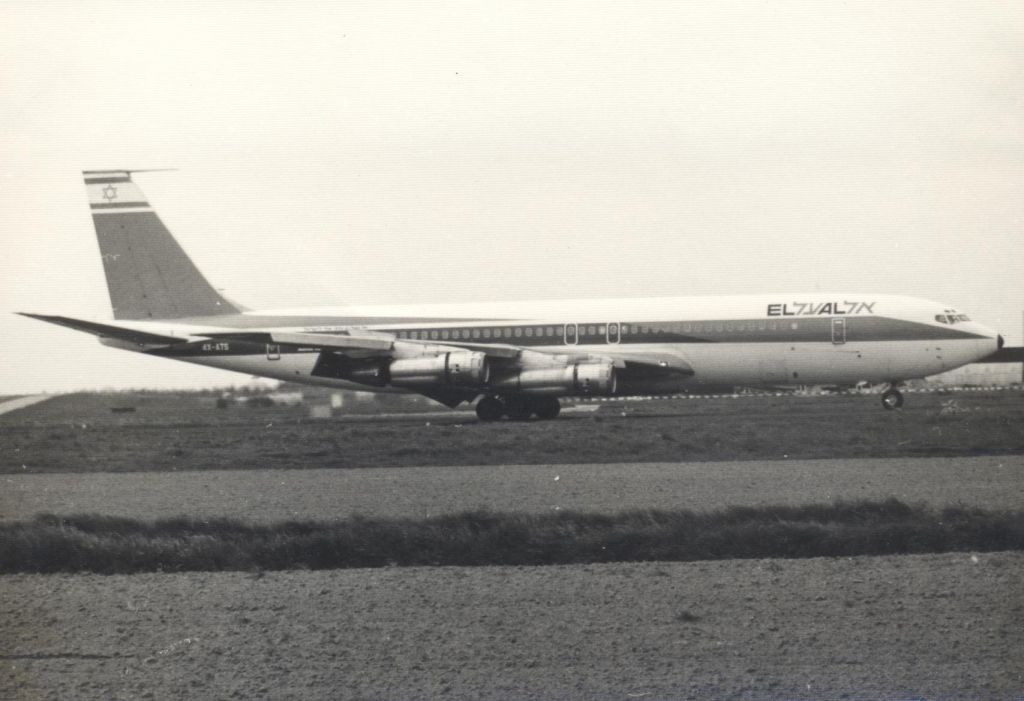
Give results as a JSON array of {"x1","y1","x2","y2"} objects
[{"x1": 83, "y1": 170, "x2": 239, "y2": 319}]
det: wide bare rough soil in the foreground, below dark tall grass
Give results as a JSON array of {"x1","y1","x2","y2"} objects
[{"x1": 0, "y1": 553, "x2": 1024, "y2": 700}]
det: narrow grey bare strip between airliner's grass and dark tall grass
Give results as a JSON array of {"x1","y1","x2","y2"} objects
[{"x1": 0, "y1": 455, "x2": 1024, "y2": 522}]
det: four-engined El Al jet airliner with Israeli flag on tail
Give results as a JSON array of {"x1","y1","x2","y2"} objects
[{"x1": 24, "y1": 170, "x2": 1004, "y2": 422}]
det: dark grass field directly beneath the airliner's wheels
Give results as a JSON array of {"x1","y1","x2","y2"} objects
[{"x1": 0, "y1": 391, "x2": 1024, "y2": 473}]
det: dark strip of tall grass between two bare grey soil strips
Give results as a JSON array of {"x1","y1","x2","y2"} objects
[{"x1": 0, "y1": 499, "x2": 1024, "y2": 573}]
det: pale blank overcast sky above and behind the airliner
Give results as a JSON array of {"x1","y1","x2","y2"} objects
[{"x1": 0, "y1": 0, "x2": 1024, "y2": 394}]
